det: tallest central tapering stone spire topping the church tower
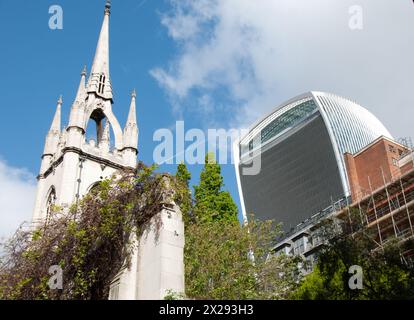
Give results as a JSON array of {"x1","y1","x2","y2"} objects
[{"x1": 88, "y1": 1, "x2": 112, "y2": 100}]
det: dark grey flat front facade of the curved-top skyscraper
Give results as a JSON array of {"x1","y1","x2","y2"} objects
[{"x1": 240, "y1": 115, "x2": 343, "y2": 231}]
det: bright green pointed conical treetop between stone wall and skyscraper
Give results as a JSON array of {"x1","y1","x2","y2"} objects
[{"x1": 194, "y1": 153, "x2": 238, "y2": 222}]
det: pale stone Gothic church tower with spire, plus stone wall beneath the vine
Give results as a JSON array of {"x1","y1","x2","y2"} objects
[{"x1": 33, "y1": 1, "x2": 184, "y2": 300}]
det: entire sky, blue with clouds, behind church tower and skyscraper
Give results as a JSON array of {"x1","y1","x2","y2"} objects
[{"x1": 0, "y1": 0, "x2": 414, "y2": 240}]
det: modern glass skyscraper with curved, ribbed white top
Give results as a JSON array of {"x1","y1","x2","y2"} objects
[{"x1": 234, "y1": 92, "x2": 392, "y2": 231}]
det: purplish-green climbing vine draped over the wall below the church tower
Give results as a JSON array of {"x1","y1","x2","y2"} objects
[{"x1": 0, "y1": 164, "x2": 180, "y2": 300}]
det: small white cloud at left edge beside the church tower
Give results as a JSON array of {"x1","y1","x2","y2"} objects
[{"x1": 0, "y1": 159, "x2": 36, "y2": 242}]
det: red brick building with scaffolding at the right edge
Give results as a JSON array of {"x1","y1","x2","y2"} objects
[{"x1": 338, "y1": 137, "x2": 414, "y2": 263}]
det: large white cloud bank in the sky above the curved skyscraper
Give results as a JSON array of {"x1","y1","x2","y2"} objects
[{"x1": 151, "y1": 0, "x2": 414, "y2": 137}]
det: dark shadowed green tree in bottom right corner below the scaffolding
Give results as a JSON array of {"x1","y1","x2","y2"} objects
[{"x1": 292, "y1": 212, "x2": 414, "y2": 300}]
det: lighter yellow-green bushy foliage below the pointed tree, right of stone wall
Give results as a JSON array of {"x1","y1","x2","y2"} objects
[{"x1": 185, "y1": 218, "x2": 300, "y2": 300}]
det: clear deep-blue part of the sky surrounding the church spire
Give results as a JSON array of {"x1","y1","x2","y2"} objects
[{"x1": 0, "y1": 0, "x2": 244, "y2": 238}]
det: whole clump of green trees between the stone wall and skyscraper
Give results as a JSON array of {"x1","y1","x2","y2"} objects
[{"x1": 182, "y1": 154, "x2": 300, "y2": 300}]
